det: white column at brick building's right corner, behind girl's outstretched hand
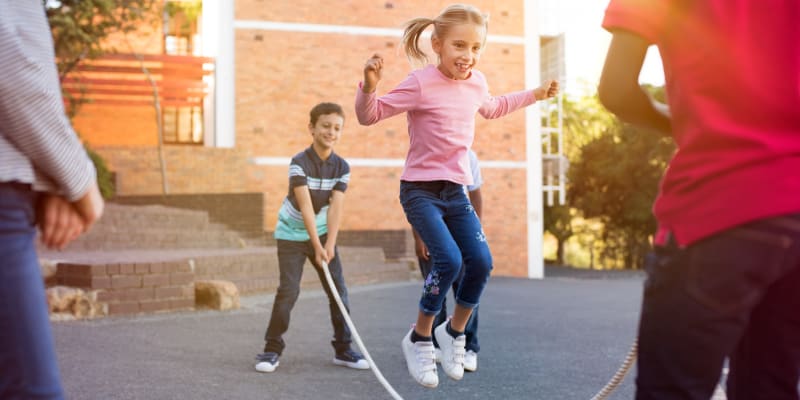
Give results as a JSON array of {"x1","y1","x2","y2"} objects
[{"x1": 523, "y1": 0, "x2": 544, "y2": 279}]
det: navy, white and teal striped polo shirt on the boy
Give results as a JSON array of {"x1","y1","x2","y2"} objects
[{"x1": 275, "y1": 147, "x2": 350, "y2": 242}]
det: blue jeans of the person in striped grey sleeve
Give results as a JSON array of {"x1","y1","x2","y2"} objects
[{"x1": 0, "y1": 183, "x2": 64, "y2": 399}]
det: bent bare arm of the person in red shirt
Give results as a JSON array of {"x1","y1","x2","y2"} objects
[{"x1": 597, "y1": 30, "x2": 672, "y2": 135}]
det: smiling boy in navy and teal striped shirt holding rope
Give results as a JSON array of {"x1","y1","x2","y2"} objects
[{"x1": 255, "y1": 103, "x2": 369, "y2": 372}]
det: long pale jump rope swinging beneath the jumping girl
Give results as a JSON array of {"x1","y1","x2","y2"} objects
[{"x1": 322, "y1": 261, "x2": 639, "y2": 400}]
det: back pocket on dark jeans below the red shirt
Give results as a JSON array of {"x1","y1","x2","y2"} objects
[{"x1": 686, "y1": 223, "x2": 793, "y2": 314}]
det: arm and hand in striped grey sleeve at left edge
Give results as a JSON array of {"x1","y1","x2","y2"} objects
[{"x1": 0, "y1": 2, "x2": 104, "y2": 242}]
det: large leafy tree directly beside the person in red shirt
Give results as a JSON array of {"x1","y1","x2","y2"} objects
[{"x1": 568, "y1": 89, "x2": 675, "y2": 268}]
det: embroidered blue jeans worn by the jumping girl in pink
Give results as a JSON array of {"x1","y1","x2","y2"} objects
[{"x1": 400, "y1": 181, "x2": 492, "y2": 316}]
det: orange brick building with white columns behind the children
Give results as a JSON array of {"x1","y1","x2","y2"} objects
[{"x1": 75, "y1": 0, "x2": 564, "y2": 277}]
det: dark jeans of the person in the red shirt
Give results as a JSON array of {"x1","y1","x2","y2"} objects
[{"x1": 636, "y1": 214, "x2": 800, "y2": 400}]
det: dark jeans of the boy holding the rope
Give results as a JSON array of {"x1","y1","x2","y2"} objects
[{"x1": 264, "y1": 235, "x2": 352, "y2": 355}]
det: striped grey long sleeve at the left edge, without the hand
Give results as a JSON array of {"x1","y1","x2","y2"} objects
[{"x1": 0, "y1": 0, "x2": 95, "y2": 201}]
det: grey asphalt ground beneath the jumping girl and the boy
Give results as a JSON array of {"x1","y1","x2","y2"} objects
[{"x1": 54, "y1": 271, "x2": 643, "y2": 400}]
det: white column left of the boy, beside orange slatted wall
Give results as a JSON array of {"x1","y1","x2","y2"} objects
[{"x1": 202, "y1": 0, "x2": 236, "y2": 148}]
